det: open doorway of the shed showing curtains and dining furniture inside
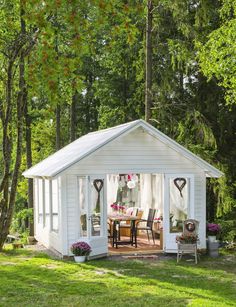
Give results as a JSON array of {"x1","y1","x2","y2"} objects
[{"x1": 107, "y1": 173, "x2": 164, "y2": 254}]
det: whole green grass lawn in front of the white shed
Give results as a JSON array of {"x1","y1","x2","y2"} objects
[{"x1": 0, "y1": 249, "x2": 236, "y2": 307}]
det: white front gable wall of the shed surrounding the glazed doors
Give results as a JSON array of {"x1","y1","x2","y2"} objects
[{"x1": 64, "y1": 128, "x2": 206, "y2": 255}]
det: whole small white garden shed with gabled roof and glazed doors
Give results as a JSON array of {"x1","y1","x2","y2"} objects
[{"x1": 23, "y1": 120, "x2": 223, "y2": 256}]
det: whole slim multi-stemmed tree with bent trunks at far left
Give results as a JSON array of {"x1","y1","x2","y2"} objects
[{"x1": 0, "y1": 1, "x2": 36, "y2": 250}]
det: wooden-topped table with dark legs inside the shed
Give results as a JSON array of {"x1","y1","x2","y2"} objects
[{"x1": 108, "y1": 214, "x2": 139, "y2": 248}]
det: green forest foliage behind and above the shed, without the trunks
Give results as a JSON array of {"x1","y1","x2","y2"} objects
[{"x1": 0, "y1": 0, "x2": 236, "y2": 235}]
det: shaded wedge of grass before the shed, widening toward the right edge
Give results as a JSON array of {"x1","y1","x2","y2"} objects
[{"x1": 88, "y1": 257, "x2": 236, "y2": 306}]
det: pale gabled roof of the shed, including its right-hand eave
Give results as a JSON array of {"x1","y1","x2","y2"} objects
[{"x1": 23, "y1": 119, "x2": 223, "y2": 178}]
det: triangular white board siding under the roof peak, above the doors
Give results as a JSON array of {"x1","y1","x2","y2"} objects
[{"x1": 66, "y1": 128, "x2": 206, "y2": 175}]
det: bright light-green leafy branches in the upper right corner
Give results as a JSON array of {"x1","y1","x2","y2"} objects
[{"x1": 199, "y1": 0, "x2": 236, "y2": 104}]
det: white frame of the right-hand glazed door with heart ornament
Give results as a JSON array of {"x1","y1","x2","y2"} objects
[{"x1": 163, "y1": 173, "x2": 195, "y2": 253}]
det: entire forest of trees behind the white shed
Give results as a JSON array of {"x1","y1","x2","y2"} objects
[{"x1": 0, "y1": 0, "x2": 236, "y2": 249}]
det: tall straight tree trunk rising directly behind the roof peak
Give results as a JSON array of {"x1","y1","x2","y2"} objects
[{"x1": 145, "y1": 0, "x2": 153, "y2": 122}]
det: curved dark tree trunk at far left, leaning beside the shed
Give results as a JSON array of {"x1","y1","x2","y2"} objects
[{"x1": 0, "y1": 3, "x2": 30, "y2": 250}]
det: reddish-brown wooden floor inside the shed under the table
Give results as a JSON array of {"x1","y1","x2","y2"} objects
[{"x1": 108, "y1": 236, "x2": 162, "y2": 255}]
